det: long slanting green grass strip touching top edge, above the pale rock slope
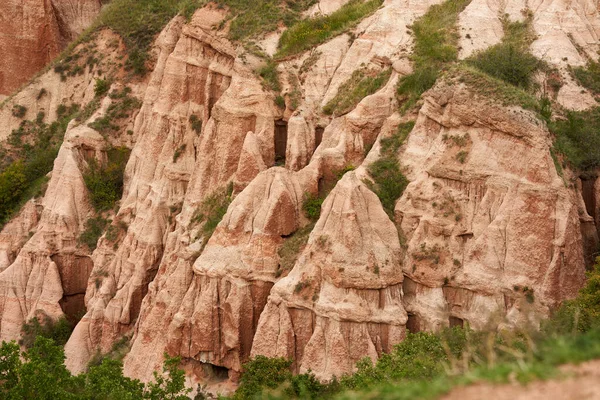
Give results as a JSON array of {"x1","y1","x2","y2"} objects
[{"x1": 276, "y1": 0, "x2": 383, "y2": 58}]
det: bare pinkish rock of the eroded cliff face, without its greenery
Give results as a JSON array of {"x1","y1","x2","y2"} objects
[{"x1": 0, "y1": 0, "x2": 600, "y2": 390}]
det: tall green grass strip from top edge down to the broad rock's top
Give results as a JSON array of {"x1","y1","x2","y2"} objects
[{"x1": 397, "y1": 0, "x2": 471, "y2": 110}]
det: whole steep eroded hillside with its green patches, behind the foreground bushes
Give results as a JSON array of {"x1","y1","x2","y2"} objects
[{"x1": 0, "y1": 0, "x2": 600, "y2": 396}]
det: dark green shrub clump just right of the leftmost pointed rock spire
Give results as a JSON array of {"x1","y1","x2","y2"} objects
[{"x1": 83, "y1": 147, "x2": 130, "y2": 212}]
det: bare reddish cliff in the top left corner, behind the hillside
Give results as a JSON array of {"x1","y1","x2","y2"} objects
[{"x1": 0, "y1": 0, "x2": 101, "y2": 95}]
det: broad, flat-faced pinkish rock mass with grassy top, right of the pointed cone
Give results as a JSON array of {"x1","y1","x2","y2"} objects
[{"x1": 396, "y1": 81, "x2": 584, "y2": 329}]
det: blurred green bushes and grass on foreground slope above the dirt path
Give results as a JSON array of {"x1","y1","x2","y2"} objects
[{"x1": 233, "y1": 258, "x2": 600, "y2": 400}]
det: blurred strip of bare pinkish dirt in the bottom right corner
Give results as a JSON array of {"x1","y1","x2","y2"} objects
[{"x1": 442, "y1": 360, "x2": 600, "y2": 400}]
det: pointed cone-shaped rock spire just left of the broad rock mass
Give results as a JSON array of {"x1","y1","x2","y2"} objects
[{"x1": 252, "y1": 173, "x2": 407, "y2": 379}]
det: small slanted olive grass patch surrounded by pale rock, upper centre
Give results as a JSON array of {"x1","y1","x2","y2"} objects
[{"x1": 323, "y1": 68, "x2": 392, "y2": 115}]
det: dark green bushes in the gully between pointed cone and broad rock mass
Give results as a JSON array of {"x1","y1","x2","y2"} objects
[{"x1": 367, "y1": 122, "x2": 415, "y2": 220}]
